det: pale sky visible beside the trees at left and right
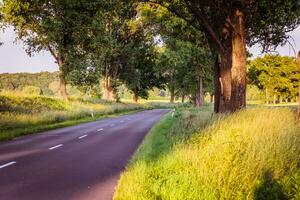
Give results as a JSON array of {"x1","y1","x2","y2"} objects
[{"x1": 0, "y1": 26, "x2": 300, "y2": 73}]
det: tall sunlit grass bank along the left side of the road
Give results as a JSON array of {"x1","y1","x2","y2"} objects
[{"x1": 0, "y1": 92, "x2": 145, "y2": 139}]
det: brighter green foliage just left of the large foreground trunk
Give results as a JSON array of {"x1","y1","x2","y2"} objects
[{"x1": 139, "y1": 3, "x2": 213, "y2": 102}]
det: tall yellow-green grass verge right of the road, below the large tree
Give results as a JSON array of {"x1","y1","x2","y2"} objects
[{"x1": 114, "y1": 108, "x2": 300, "y2": 200}]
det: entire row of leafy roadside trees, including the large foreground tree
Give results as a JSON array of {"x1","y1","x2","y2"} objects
[{"x1": 1, "y1": 0, "x2": 300, "y2": 112}]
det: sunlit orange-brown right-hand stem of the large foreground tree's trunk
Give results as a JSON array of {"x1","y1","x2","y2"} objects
[{"x1": 231, "y1": 9, "x2": 247, "y2": 112}]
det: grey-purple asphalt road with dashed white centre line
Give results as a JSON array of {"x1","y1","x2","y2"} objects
[{"x1": 0, "y1": 109, "x2": 168, "y2": 200}]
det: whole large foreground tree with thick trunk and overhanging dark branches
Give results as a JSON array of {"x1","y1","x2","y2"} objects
[{"x1": 147, "y1": 0, "x2": 300, "y2": 112}]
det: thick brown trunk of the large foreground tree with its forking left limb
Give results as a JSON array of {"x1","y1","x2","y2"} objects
[{"x1": 189, "y1": 1, "x2": 246, "y2": 112}]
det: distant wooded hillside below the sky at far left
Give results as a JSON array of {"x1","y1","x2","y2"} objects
[{"x1": 0, "y1": 72, "x2": 59, "y2": 96}]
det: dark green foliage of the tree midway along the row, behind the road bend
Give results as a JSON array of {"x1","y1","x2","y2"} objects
[{"x1": 119, "y1": 21, "x2": 163, "y2": 99}]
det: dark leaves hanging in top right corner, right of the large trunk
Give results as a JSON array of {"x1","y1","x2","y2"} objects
[{"x1": 245, "y1": 0, "x2": 300, "y2": 50}]
